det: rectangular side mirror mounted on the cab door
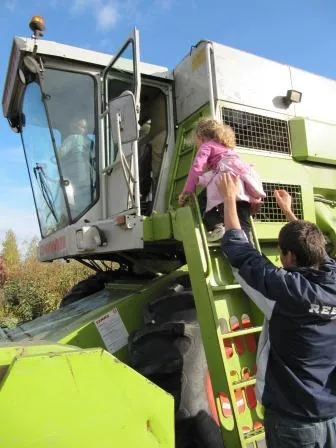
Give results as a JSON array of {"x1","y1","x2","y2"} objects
[{"x1": 109, "y1": 90, "x2": 139, "y2": 143}]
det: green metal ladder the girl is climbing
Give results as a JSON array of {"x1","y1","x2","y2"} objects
[{"x1": 174, "y1": 197, "x2": 266, "y2": 448}]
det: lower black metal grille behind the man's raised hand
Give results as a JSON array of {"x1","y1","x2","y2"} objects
[{"x1": 255, "y1": 182, "x2": 303, "y2": 222}]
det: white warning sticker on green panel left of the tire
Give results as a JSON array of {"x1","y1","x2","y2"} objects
[{"x1": 95, "y1": 308, "x2": 128, "y2": 353}]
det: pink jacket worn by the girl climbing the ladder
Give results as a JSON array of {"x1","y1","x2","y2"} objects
[{"x1": 183, "y1": 140, "x2": 266, "y2": 211}]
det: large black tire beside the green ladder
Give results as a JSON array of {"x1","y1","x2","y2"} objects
[{"x1": 129, "y1": 276, "x2": 224, "y2": 448}]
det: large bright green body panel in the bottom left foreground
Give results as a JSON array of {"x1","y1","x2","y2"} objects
[{"x1": 0, "y1": 346, "x2": 174, "y2": 448}]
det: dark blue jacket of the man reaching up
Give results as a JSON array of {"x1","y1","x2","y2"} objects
[{"x1": 222, "y1": 229, "x2": 336, "y2": 421}]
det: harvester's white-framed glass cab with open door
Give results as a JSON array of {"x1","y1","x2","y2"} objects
[{"x1": 3, "y1": 21, "x2": 174, "y2": 266}]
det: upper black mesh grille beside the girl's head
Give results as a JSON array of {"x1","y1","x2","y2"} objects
[{"x1": 222, "y1": 107, "x2": 291, "y2": 154}]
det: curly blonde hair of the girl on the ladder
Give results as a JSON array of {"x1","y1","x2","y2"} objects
[{"x1": 195, "y1": 118, "x2": 236, "y2": 148}]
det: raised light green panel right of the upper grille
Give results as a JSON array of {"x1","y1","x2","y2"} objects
[{"x1": 289, "y1": 118, "x2": 336, "y2": 165}]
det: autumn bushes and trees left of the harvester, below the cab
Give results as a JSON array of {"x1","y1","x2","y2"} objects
[{"x1": 0, "y1": 234, "x2": 92, "y2": 327}]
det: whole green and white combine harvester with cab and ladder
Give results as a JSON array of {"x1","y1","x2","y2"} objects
[{"x1": 0, "y1": 16, "x2": 336, "y2": 448}]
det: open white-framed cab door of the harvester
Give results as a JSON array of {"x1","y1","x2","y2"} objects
[{"x1": 101, "y1": 29, "x2": 142, "y2": 220}]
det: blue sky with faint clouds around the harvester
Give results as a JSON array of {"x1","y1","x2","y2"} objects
[{"x1": 0, "y1": 0, "x2": 336, "y2": 245}]
